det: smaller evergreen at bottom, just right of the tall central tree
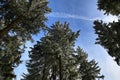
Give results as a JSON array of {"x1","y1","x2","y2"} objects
[{"x1": 76, "y1": 47, "x2": 100, "y2": 80}]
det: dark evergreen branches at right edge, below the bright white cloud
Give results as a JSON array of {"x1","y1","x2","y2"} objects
[{"x1": 94, "y1": 21, "x2": 120, "y2": 64}]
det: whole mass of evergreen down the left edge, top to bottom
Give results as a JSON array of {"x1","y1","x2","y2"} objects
[{"x1": 0, "y1": 0, "x2": 50, "y2": 80}]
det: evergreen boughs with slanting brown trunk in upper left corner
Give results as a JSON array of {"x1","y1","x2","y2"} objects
[{"x1": 0, "y1": 0, "x2": 50, "y2": 39}]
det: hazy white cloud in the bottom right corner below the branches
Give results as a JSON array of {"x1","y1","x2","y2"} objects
[{"x1": 104, "y1": 56, "x2": 120, "y2": 80}]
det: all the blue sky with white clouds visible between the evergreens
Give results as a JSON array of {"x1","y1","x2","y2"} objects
[{"x1": 15, "y1": 0, "x2": 120, "y2": 80}]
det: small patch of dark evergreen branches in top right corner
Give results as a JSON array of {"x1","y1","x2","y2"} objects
[{"x1": 98, "y1": 0, "x2": 120, "y2": 15}]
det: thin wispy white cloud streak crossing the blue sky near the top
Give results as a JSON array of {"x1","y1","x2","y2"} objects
[{"x1": 47, "y1": 12, "x2": 118, "y2": 22}]
